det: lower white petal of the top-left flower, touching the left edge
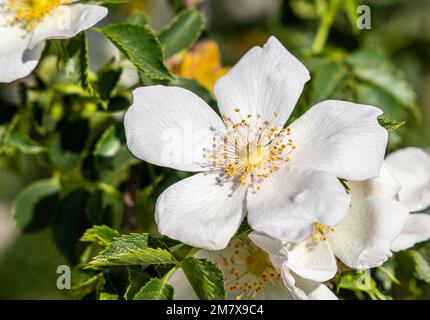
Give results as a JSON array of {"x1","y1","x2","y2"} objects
[{"x1": 0, "y1": 27, "x2": 45, "y2": 82}]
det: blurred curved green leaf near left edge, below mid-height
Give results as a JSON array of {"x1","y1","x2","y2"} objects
[{"x1": 12, "y1": 179, "x2": 60, "y2": 230}]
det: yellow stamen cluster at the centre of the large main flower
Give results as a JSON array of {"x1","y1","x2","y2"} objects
[{"x1": 204, "y1": 108, "x2": 296, "y2": 190}]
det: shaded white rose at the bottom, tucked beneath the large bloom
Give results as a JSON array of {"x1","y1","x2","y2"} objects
[{"x1": 167, "y1": 232, "x2": 337, "y2": 300}]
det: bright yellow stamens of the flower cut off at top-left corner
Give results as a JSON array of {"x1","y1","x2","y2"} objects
[{"x1": 0, "y1": 0, "x2": 65, "y2": 30}]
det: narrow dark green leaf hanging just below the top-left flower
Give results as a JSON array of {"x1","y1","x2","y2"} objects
[{"x1": 64, "y1": 32, "x2": 94, "y2": 94}]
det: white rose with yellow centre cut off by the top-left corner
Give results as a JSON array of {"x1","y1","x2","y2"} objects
[{"x1": 0, "y1": 0, "x2": 108, "y2": 82}]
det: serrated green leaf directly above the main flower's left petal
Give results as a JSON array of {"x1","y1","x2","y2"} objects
[{"x1": 102, "y1": 23, "x2": 172, "y2": 80}]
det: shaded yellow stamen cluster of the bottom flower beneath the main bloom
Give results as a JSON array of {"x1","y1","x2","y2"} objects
[{"x1": 219, "y1": 240, "x2": 281, "y2": 300}]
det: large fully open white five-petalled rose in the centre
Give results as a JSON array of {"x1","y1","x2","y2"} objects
[{"x1": 124, "y1": 37, "x2": 388, "y2": 250}]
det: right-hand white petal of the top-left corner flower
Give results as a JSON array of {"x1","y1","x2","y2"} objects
[{"x1": 29, "y1": 4, "x2": 108, "y2": 48}]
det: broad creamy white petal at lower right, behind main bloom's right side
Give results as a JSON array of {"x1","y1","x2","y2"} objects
[{"x1": 328, "y1": 196, "x2": 409, "y2": 269}]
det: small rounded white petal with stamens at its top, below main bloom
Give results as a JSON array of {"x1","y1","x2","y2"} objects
[{"x1": 286, "y1": 238, "x2": 337, "y2": 282}]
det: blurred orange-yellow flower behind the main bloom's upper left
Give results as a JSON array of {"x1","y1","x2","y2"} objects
[{"x1": 168, "y1": 40, "x2": 229, "y2": 91}]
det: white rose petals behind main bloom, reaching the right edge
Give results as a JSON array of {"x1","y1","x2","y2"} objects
[{"x1": 287, "y1": 148, "x2": 430, "y2": 281}]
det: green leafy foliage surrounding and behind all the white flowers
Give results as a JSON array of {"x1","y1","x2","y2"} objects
[{"x1": 0, "y1": 0, "x2": 430, "y2": 299}]
